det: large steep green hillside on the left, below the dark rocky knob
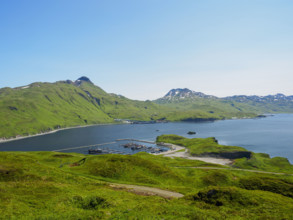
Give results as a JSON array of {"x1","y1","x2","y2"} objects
[{"x1": 0, "y1": 82, "x2": 113, "y2": 137}]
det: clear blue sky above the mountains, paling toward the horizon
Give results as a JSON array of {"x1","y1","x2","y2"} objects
[{"x1": 0, "y1": 0, "x2": 293, "y2": 100}]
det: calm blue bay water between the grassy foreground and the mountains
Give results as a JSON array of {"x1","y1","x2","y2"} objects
[{"x1": 0, "y1": 114, "x2": 293, "y2": 163}]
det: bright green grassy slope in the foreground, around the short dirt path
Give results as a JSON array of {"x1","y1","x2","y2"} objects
[{"x1": 0, "y1": 152, "x2": 293, "y2": 219}]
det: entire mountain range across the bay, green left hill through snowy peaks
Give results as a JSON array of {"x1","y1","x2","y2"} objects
[{"x1": 0, "y1": 76, "x2": 293, "y2": 138}]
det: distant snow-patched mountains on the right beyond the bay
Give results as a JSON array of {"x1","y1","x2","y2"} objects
[{"x1": 154, "y1": 88, "x2": 293, "y2": 113}]
